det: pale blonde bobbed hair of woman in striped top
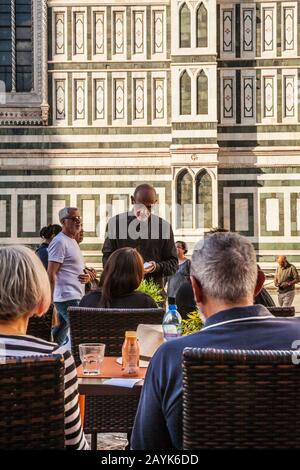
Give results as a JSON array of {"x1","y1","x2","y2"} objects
[{"x1": 0, "y1": 246, "x2": 51, "y2": 322}]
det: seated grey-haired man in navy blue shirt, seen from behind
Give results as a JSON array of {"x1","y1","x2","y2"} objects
[{"x1": 131, "y1": 232, "x2": 300, "y2": 450}]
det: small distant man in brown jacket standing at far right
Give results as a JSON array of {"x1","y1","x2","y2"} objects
[{"x1": 274, "y1": 256, "x2": 300, "y2": 307}]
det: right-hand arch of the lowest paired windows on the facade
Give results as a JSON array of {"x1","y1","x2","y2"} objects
[{"x1": 196, "y1": 170, "x2": 212, "y2": 228}]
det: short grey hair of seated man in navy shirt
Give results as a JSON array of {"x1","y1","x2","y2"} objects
[{"x1": 191, "y1": 232, "x2": 257, "y2": 303}]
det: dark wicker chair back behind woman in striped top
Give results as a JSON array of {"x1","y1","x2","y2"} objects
[{"x1": 0, "y1": 355, "x2": 65, "y2": 450}]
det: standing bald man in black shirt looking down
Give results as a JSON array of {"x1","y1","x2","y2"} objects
[{"x1": 102, "y1": 184, "x2": 178, "y2": 287}]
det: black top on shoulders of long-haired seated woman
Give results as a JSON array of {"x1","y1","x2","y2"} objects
[{"x1": 79, "y1": 290, "x2": 157, "y2": 308}]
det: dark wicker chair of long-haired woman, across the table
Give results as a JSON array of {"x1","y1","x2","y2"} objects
[{"x1": 68, "y1": 307, "x2": 164, "y2": 449}]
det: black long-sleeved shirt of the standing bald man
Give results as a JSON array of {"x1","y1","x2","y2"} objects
[{"x1": 102, "y1": 212, "x2": 178, "y2": 287}]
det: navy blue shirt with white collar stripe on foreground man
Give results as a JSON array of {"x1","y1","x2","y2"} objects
[{"x1": 131, "y1": 305, "x2": 300, "y2": 450}]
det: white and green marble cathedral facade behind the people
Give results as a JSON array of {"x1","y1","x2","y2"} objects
[{"x1": 0, "y1": 0, "x2": 300, "y2": 267}]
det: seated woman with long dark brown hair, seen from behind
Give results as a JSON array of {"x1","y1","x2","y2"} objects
[{"x1": 80, "y1": 248, "x2": 157, "y2": 308}]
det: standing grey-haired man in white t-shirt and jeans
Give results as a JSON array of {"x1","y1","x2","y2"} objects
[{"x1": 48, "y1": 207, "x2": 90, "y2": 345}]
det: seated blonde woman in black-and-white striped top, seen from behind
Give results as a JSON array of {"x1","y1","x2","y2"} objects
[{"x1": 0, "y1": 246, "x2": 89, "y2": 450}]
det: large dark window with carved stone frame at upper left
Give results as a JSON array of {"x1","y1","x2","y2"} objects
[{"x1": 0, "y1": 0, "x2": 49, "y2": 125}]
